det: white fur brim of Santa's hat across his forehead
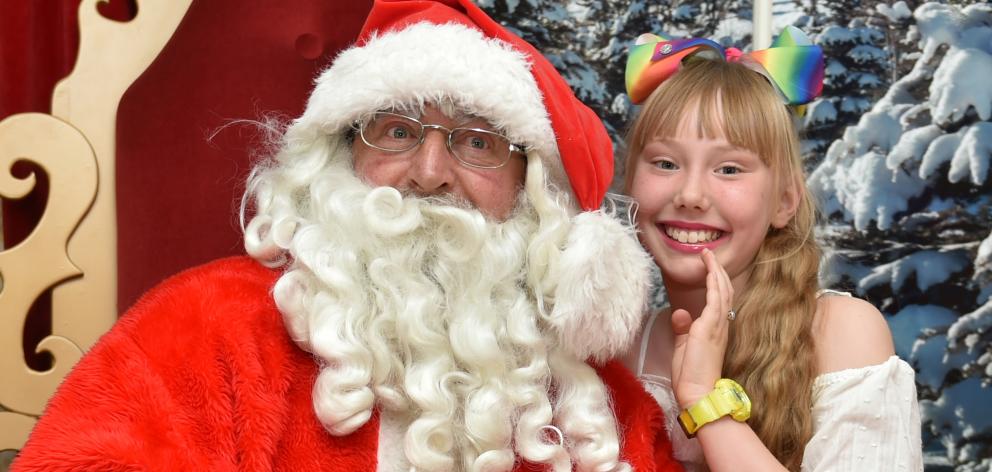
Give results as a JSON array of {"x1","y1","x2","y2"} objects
[{"x1": 297, "y1": 22, "x2": 571, "y2": 195}]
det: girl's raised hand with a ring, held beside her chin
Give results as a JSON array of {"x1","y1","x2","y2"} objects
[{"x1": 672, "y1": 249, "x2": 734, "y2": 408}]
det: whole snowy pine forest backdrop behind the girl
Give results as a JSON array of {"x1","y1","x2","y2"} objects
[{"x1": 477, "y1": 0, "x2": 992, "y2": 472}]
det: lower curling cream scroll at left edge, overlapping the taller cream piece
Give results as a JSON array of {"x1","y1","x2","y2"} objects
[{"x1": 0, "y1": 113, "x2": 97, "y2": 449}]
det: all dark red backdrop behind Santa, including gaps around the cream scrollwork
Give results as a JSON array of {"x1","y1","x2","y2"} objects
[{"x1": 0, "y1": 0, "x2": 371, "y2": 366}]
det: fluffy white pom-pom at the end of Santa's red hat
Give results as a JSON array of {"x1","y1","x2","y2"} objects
[{"x1": 549, "y1": 211, "x2": 653, "y2": 361}]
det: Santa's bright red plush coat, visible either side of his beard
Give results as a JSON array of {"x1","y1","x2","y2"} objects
[{"x1": 13, "y1": 258, "x2": 681, "y2": 472}]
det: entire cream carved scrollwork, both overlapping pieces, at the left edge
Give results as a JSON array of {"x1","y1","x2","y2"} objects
[{"x1": 0, "y1": 0, "x2": 192, "y2": 450}]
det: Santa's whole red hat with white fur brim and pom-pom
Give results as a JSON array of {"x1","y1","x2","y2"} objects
[{"x1": 297, "y1": 0, "x2": 651, "y2": 359}]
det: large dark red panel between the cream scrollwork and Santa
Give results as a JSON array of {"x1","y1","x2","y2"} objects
[{"x1": 117, "y1": 0, "x2": 371, "y2": 310}]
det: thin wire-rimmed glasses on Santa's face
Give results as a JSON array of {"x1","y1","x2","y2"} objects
[{"x1": 355, "y1": 111, "x2": 524, "y2": 169}]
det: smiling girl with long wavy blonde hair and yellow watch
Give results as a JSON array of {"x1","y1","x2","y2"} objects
[{"x1": 625, "y1": 34, "x2": 922, "y2": 471}]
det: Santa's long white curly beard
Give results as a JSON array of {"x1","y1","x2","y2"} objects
[{"x1": 248, "y1": 159, "x2": 625, "y2": 471}]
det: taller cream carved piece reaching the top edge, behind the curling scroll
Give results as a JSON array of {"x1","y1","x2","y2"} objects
[{"x1": 52, "y1": 0, "x2": 198, "y2": 356}]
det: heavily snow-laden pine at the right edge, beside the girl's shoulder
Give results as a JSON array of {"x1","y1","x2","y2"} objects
[{"x1": 810, "y1": 3, "x2": 992, "y2": 472}]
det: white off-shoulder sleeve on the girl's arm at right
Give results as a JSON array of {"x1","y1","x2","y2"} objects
[{"x1": 802, "y1": 356, "x2": 923, "y2": 472}]
